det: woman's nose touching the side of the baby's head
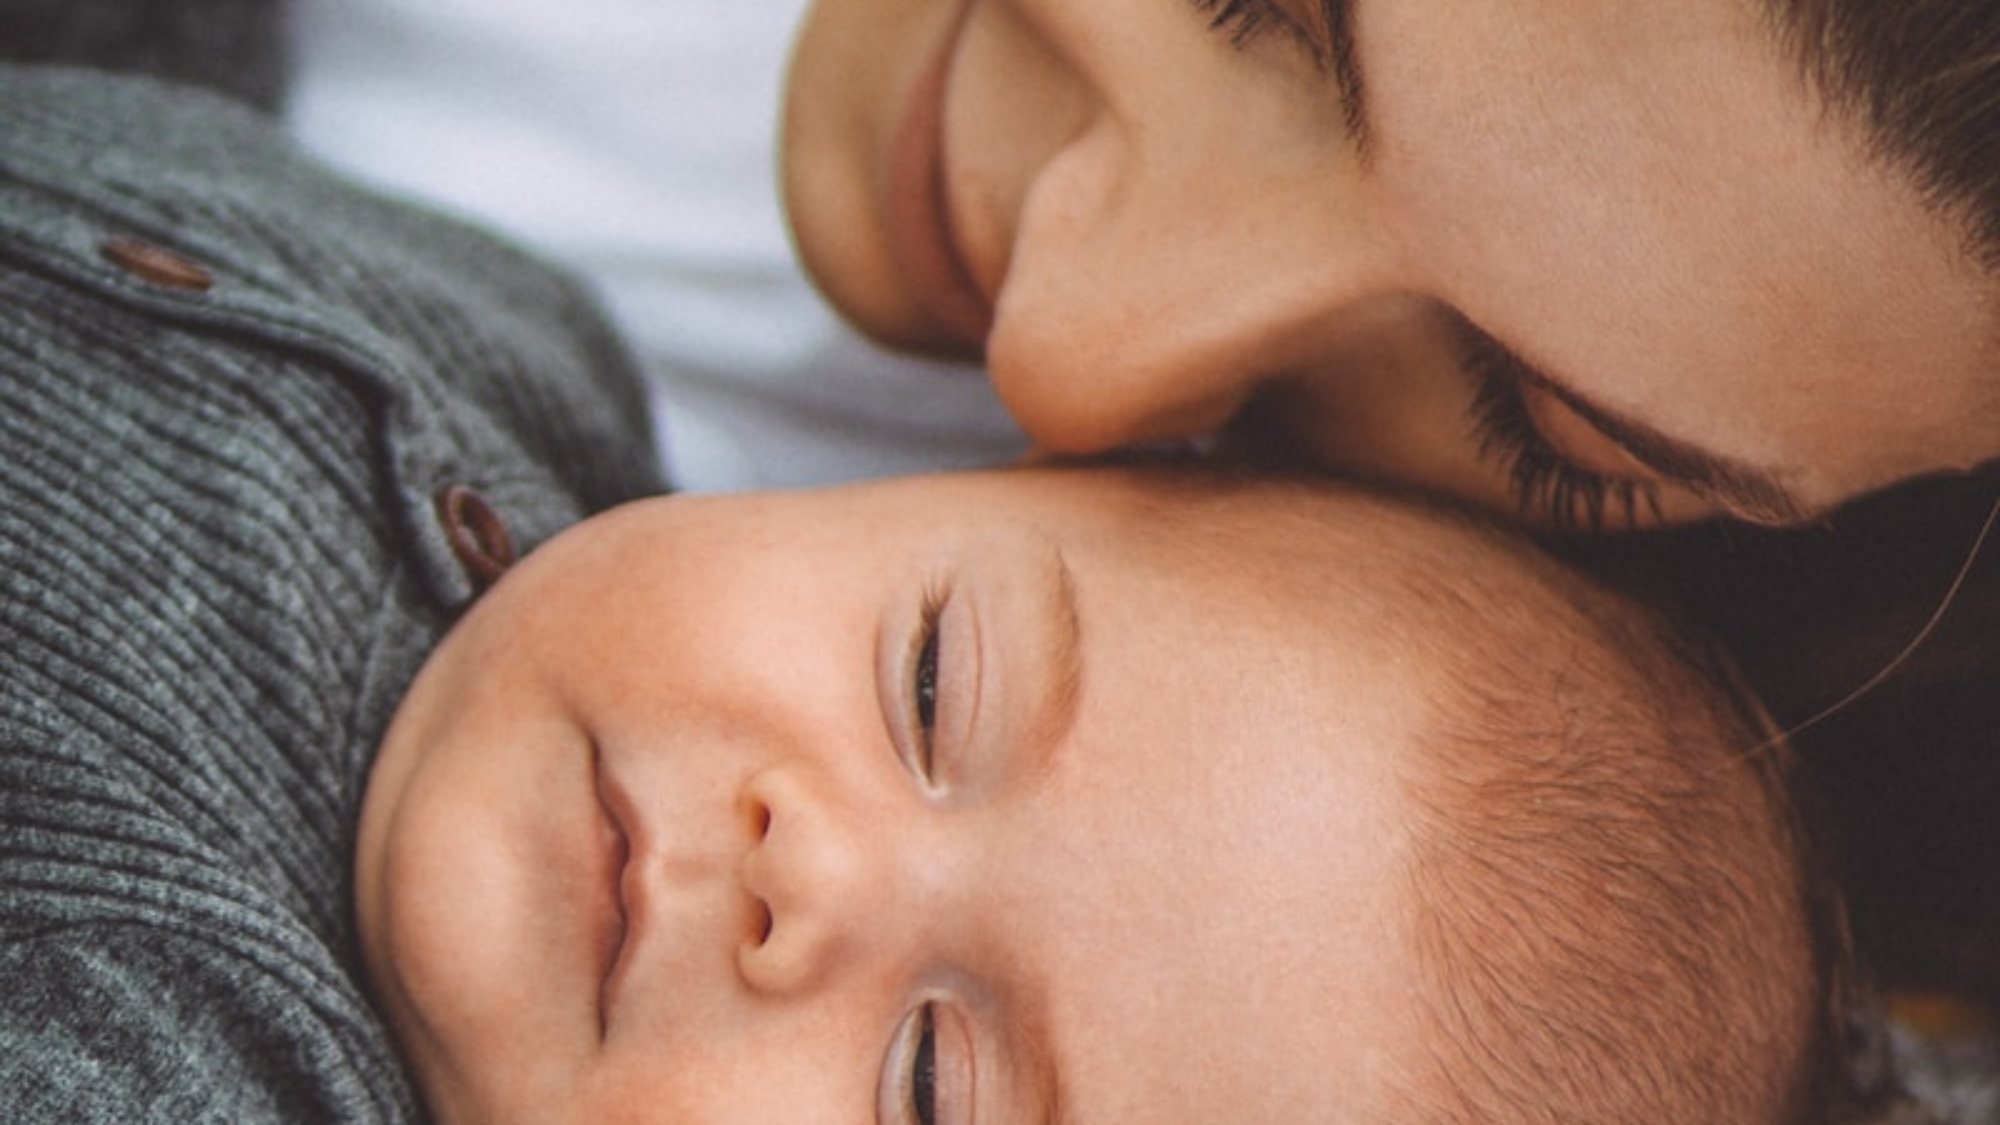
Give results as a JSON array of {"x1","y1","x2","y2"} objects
[{"x1": 986, "y1": 155, "x2": 1400, "y2": 452}]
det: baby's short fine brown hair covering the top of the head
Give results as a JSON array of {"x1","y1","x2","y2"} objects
[{"x1": 1396, "y1": 508, "x2": 1890, "y2": 1125}]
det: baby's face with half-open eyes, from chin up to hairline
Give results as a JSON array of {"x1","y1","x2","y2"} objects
[{"x1": 356, "y1": 470, "x2": 1422, "y2": 1125}]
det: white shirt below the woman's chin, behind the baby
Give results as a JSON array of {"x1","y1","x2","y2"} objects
[{"x1": 288, "y1": 0, "x2": 1026, "y2": 490}]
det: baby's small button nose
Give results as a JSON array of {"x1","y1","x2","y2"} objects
[{"x1": 738, "y1": 767, "x2": 934, "y2": 993}]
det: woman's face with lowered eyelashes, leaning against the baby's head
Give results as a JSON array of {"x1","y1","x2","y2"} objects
[{"x1": 784, "y1": 0, "x2": 2000, "y2": 524}]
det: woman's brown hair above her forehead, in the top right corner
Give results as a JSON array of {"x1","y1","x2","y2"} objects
[{"x1": 1764, "y1": 0, "x2": 2000, "y2": 274}]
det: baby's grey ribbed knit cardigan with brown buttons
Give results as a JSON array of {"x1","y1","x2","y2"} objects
[{"x1": 0, "y1": 70, "x2": 660, "y2": 1123}]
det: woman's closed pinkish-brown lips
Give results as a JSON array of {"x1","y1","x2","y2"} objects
[{"x1": 884, "y1": 6, "x2": 992, "y2": 350}]
